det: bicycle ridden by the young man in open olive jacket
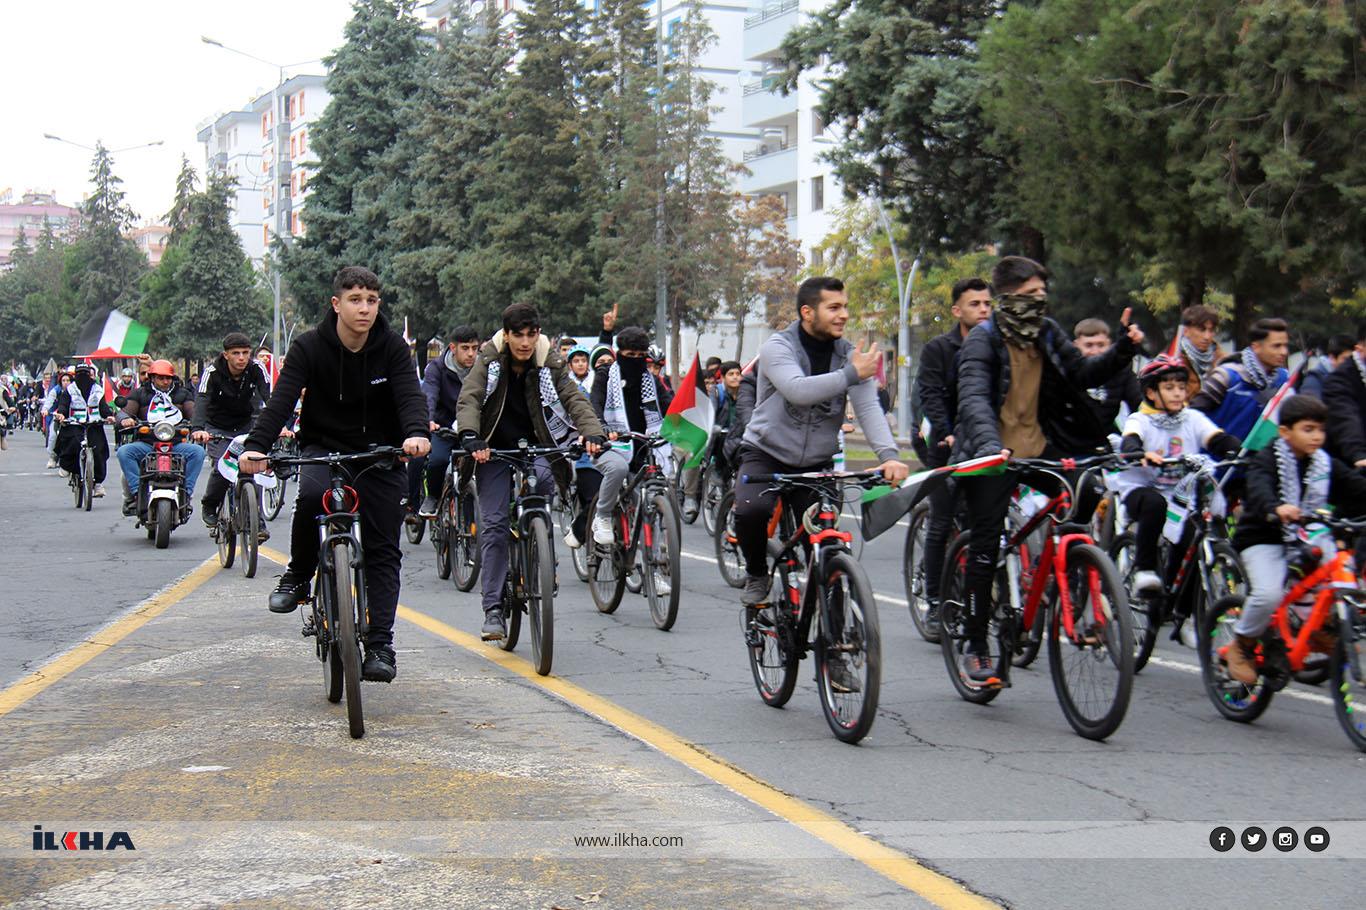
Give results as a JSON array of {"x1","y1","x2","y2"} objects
[{"x1": 488, "y1": 440, "x2": 579, "y2": 676}]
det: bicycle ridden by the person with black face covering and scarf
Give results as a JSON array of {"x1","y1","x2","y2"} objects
[{"x1": 589, "y1": 433, "x2": 683, "y2": 631}]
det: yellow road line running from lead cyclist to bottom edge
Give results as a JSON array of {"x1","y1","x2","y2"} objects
[{"x1": 261, "y1": 547, "x2": 999, "y2": 910}]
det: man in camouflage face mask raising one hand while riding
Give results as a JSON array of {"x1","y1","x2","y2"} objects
[{"x1": 953, "y1": 256, "x2": 1143, "y2": 686}]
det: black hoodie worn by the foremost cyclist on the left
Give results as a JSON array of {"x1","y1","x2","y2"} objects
[{"x1": 246, "y1": 312, "x2": 429, "y2": 452}]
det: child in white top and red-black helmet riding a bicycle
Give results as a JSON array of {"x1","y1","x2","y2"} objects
[{"x1": 1115, "y1": 354, "x2": 1239, "y2": 594}]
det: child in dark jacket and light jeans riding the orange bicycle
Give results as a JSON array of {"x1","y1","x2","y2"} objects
[{"x1": 1225, "y1": 395, "x2": 1366, "y2": 686}]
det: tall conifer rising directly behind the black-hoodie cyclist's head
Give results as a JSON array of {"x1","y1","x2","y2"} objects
[{"x1": 284, "y1": 0, "x2": 430, "y2": 317}]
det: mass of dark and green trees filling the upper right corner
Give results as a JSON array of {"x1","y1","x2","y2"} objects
[{"x1": 783, "y1": 0, "x2": 1366, "y2": 340}]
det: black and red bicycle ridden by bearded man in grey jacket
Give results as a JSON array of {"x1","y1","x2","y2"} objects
[{"x1": 740, "y1": 471, "x2": 882, "y2": 743}]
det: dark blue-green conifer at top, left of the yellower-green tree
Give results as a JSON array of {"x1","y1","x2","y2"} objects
[{"x1": 783, "y1": 0, "x2": 1010, "y2": 256}]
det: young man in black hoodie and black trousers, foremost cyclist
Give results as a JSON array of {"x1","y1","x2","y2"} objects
[{"x1": 239, "y1": 265, "x2": 432, "y2": 682}]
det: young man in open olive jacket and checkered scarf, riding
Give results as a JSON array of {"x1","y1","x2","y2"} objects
[{"x1": 456, "y1": 303, "x2": 626, "y2": 641}]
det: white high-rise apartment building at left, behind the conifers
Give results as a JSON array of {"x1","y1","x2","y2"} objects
[{"x1": 198, "y1": 75, "x2": 332, "y2": 266}]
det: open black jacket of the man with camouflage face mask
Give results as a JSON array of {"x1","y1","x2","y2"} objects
[{"x1": 953, "y1": 318, "x2": 1138, "y2": 460}]
